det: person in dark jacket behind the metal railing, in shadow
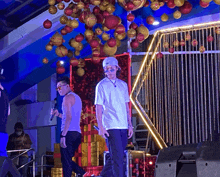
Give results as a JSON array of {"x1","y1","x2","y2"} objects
[{"x1": 7, "y1": 122, "x2": 32, "y2": 177}]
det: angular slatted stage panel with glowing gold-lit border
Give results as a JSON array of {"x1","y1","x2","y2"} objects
[{"x1": 130, "y1": 21, "x2": 220, "y2": 149}]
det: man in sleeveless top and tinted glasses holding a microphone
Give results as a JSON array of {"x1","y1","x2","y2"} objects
[{"x1": 51, "y1": 76, "x2": 88, "y2": 177}]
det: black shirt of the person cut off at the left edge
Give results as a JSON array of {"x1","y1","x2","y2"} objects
[{"x1": 0, "y1": 88, "x2": 9, "y2": 133}]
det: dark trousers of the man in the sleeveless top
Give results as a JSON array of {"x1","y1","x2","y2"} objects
[{"x1": 60, "y1": 131, "x2": 85, "y2": 177}]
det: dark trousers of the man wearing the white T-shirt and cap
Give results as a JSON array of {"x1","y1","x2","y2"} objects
[{"x1": 100, "y1": 129, "x2": 128, "y2": 177}]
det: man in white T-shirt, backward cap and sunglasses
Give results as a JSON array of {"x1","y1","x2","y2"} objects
[{"x1": 95, "y1": 57, "x2": 133, "y2": 177}]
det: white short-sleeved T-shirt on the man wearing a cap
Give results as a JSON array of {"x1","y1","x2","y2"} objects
[{"x1": 95, "y1": 78, "x2": 130, "y2": 130}]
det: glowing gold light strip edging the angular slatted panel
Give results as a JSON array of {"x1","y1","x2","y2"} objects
[{"x1": 130, "y1": 21, "x2": 220, "y2": 149}]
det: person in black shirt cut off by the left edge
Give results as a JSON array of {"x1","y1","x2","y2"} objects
[{"x1": 0, "y1": 65, "x2": 20, "y2": 177}]
